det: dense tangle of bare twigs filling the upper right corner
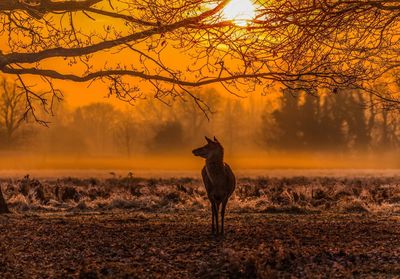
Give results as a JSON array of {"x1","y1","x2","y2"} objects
[{"x1": 253, "y1": 0, "x2": 400, "y2": 105}]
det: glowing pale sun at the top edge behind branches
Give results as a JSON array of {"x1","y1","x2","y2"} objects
[{"x1": 222, "y1": 0, "x2": 256, "y2": 26}]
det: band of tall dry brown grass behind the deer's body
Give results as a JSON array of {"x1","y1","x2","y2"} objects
[{"x1": 0, "y1": 176, "x2": 400, "y2": 214}]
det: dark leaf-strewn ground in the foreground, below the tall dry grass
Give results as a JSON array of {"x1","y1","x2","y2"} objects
[{"x1": 0, "y1": 212, "x2": 400, "y2": 278}]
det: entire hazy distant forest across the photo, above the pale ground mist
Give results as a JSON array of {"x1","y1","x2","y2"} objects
[{"x1": 0, "y1": 77, "x2": 400, "y2": 157}]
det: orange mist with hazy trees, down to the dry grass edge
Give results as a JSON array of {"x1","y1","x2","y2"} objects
[{"x1": 0, "y1": 83, "x2": 400, "y2": 170}]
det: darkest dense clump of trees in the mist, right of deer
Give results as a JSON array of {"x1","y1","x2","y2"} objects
[{"x1": 264, "y1": 89, "x2": 371, "y2": 150}]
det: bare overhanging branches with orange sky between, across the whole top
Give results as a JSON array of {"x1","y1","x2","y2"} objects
[{"x1": 0, "y1": 0, "x2": 400, "y2": 121}]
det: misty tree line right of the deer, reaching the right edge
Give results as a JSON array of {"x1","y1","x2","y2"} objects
[{"x1": 262, "y1": 89, "x2": 399, "y2": 152}]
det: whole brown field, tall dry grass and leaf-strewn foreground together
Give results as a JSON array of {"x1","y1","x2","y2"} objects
[{"x1": 0, "y1": 173, "x2": 400, "y2": 278}]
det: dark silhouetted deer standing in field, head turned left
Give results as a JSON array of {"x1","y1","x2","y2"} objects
[{"x1": 192, "y1": 137, "x2": 236, "y2": 235}]
